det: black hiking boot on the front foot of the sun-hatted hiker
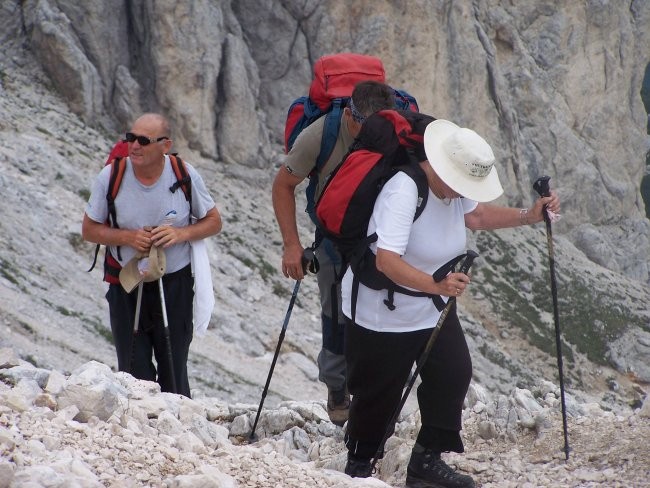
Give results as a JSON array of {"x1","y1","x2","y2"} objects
[{"x1": 406, "y1": 446, "x2": 476, "y2": 488}]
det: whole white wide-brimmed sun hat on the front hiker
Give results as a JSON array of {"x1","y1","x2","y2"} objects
[{"x1": 424, "y1": 119, "x2": 503, "y2": 202}]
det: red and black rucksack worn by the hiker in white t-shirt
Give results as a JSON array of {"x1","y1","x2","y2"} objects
[{"x1": 316, "y1": 110, "x2": 456, "y2": 320}]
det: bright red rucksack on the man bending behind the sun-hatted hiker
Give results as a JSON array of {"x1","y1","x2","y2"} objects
[{"x1": 284, "y1": 53, "x2": 418, "y2": 214}]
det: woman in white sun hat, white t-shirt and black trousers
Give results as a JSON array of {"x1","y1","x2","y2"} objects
[{"x1": 342, "y1": 120, "x2": 560, "y2": 488}]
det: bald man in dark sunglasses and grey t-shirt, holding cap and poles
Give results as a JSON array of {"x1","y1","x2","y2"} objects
[{"x1": 82, "y1": 113, "x2": 221, "y2": 397}]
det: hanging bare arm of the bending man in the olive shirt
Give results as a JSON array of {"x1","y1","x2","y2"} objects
[{"x1": 272, "y1": 166, "x2": 304, "y2": 280}]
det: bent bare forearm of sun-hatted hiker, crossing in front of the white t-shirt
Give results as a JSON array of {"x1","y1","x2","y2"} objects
[{"x1": 377, "y1": 248, "x2": 469, "y2": 297}]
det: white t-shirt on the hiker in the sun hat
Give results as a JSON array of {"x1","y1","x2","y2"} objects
[{"x1": 341, "y1": 172, "x2": 478, "y2": 332}]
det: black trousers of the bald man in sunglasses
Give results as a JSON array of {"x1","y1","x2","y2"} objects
[{"x1": 106, "y1": 265, "x2": 194, "y2": 397}]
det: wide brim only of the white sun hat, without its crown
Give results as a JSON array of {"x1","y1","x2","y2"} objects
[{"x1": 424, "y1": 120, "x2": 503, "y2": 202}]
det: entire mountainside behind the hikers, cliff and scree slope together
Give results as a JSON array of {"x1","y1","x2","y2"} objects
[{"x1": 0, "y1": 0, "x2": 650, "y2": 442}]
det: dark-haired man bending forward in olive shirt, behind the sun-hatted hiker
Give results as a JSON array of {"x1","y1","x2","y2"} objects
[{"x1": 273, "y1": 81, "x2": 395, "y2": 425}]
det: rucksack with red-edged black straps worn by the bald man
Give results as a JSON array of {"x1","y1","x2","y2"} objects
[{"x1": 88, "y1": 140, "x2": 192, "y2": 285}]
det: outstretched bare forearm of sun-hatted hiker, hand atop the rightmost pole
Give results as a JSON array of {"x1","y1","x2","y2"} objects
[{"x1": 465, "y1": 192, "x2": 560, "y2": 230}]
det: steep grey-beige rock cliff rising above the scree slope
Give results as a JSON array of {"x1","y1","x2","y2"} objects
[{"x1": 13, "y1": 0, "x2": 650, "y2": 281}]
